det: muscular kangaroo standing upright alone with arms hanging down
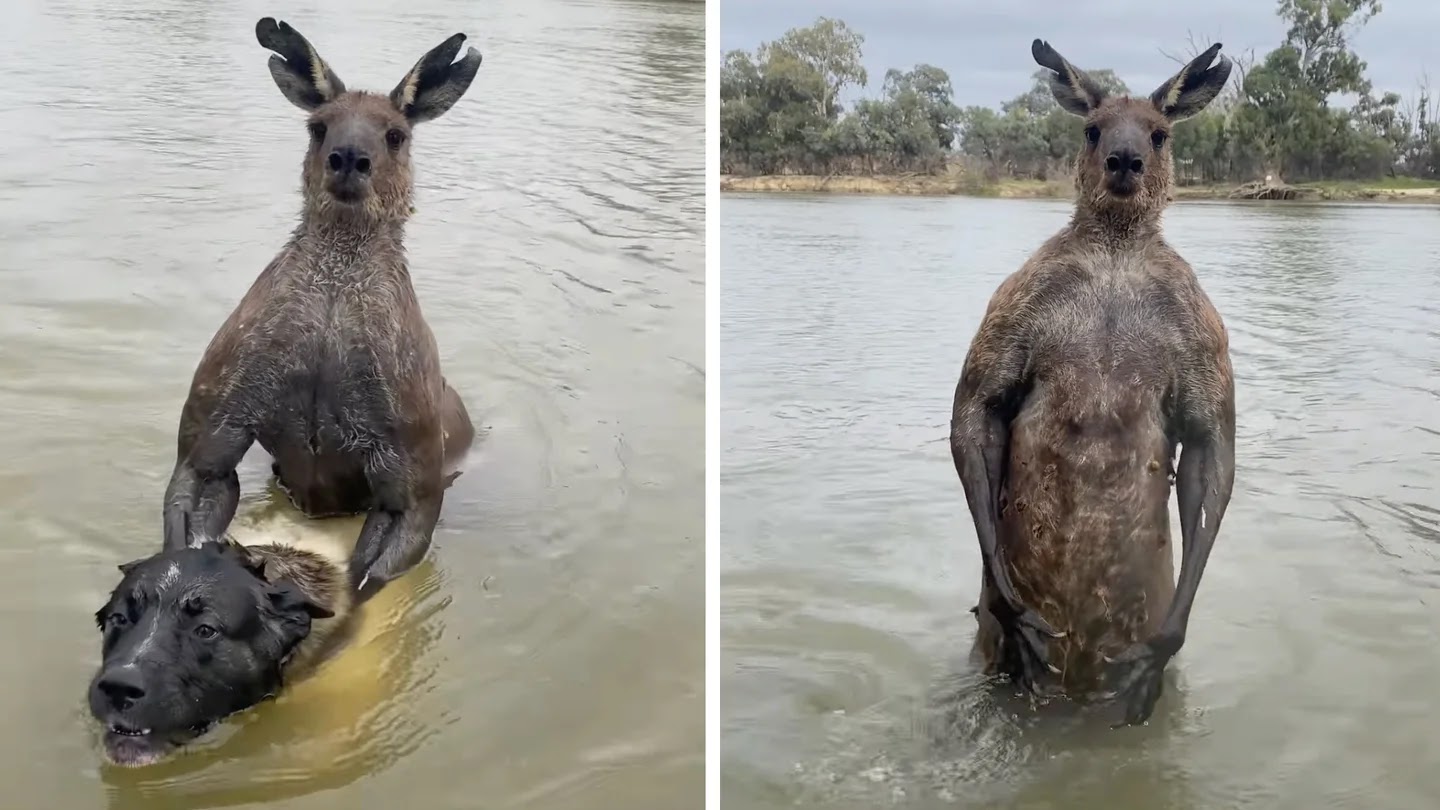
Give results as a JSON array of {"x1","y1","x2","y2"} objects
[{"x1": 950, "y1": 39, "x2": 1236, "y2": 725}]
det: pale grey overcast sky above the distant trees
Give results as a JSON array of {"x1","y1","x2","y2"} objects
[{"x1": 720, "y1": 0, "x2": 1440, "y2": 107}]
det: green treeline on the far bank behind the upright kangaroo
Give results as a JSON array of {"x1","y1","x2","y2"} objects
[{"x1": 720, "y1": 0, "x2": 1440, "y2": 183}]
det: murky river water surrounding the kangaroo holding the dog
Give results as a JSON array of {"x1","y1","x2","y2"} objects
[{"x1": 0, "y1": 0, "x2": 704, "y2": 810}]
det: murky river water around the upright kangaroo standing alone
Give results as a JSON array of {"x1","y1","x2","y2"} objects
[{"x1": 721, "y1": 196, "x2": 1440, "y2": 810}]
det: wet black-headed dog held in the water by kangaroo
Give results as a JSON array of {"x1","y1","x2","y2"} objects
[{"x1": 89, "y1": 539, "x2": 351, "y2": 767}]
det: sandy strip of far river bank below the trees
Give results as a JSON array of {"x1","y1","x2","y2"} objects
[{"x1": 720, "y1": 173, "x2": 1440, "y2": 203}]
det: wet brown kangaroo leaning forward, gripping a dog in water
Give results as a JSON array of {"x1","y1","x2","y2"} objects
[{"x1": 163, "y1": 17, "x2": 481, "y2": 601}]
